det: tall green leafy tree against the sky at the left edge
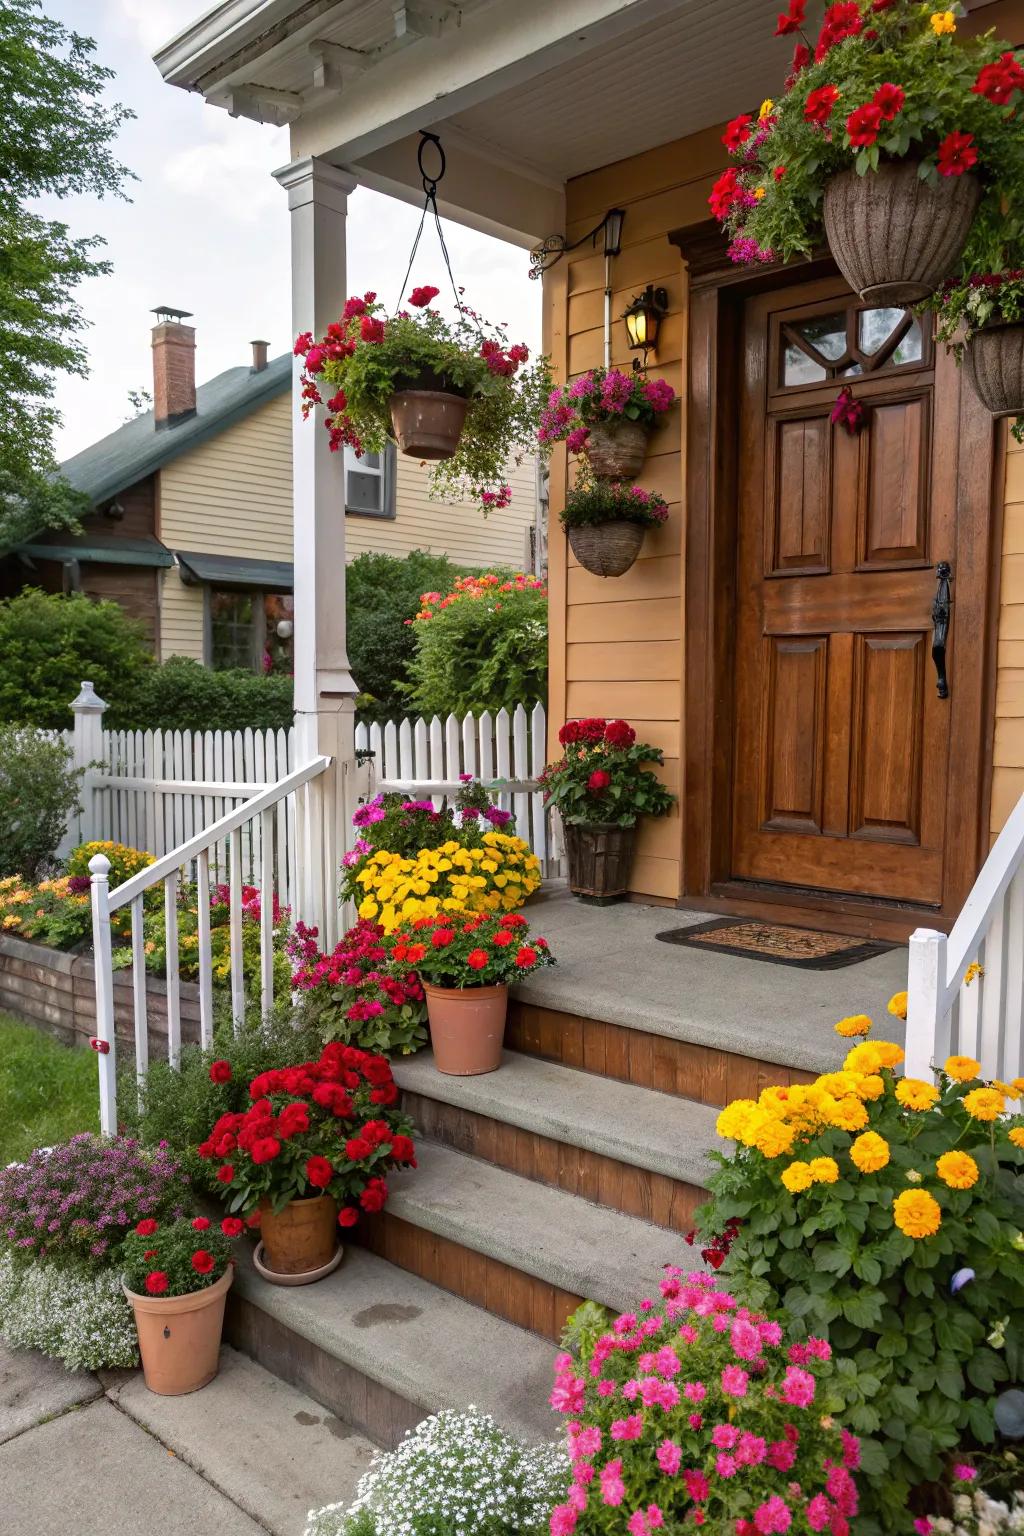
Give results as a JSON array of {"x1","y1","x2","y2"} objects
[{"x1": 0, "y1": 0, "x2": 132, "y2": 551}]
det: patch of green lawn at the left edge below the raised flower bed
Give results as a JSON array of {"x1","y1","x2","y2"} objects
[{"x1": 0, "y1": 1014, "x2": 100, "y2": 1167}]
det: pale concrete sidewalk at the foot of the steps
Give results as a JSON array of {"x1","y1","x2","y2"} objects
[{"x1": 0, "y1": 1344, "x2": 373, "y2": 1536}]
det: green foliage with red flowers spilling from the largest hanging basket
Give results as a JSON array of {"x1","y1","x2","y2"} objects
[{"x1": 712, "y1": 0, "x2": 1024, "y2": 273}]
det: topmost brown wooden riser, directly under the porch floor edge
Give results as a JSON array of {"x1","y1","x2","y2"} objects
[{"x1": 505, "y1": 998, "x2": 814, "y2": 1104}]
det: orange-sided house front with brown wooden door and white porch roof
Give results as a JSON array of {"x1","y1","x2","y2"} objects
[{"x1": 158, "y1": 0, "x2": 1024, "y2": 935}]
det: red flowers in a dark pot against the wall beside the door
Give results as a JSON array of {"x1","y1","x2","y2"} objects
[{"x1": 540, "y1": 719, "x2": 676, "y2": 905}]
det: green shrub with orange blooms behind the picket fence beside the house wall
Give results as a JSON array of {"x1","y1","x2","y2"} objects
[{"x1": 407, "y1": 571, "x2": 548, "y2": 719}]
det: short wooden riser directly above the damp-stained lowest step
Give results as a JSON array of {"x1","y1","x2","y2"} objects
[{"x1": 360, "y1": 1210, "x2": 585, "y2": 1345}]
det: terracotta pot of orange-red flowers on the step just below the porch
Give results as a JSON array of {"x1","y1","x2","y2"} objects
[{"x1": 388, "y1": 912, "x2": 554, "y2": 1077}]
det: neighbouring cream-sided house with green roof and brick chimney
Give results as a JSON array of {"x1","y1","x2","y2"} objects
[{"x1": 0, "y1": 309, "x2": 537, "y2": 668}]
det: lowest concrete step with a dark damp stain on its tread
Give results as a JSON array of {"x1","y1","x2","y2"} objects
[{"x1": 227, "y1": 1218, "x2": 557, "y2": 1445}]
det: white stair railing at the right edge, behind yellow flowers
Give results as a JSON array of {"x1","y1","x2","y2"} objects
[{"x1": 906, "y1": 796, "x2": 1024, "y2": 1081}]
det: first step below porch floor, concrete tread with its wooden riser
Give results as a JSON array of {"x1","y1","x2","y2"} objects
[{"x1": 395, "y1": 1051, "x2": 718, "y2": 1230}]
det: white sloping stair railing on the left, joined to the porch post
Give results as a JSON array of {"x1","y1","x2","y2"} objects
[{"x1": 89, "y1": 757, "x2": 333, "y2": 1135}]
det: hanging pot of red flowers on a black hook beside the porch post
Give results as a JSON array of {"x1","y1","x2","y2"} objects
[{"x1": 295, "y1": 284, "x2": 551, "y2": 511}]
